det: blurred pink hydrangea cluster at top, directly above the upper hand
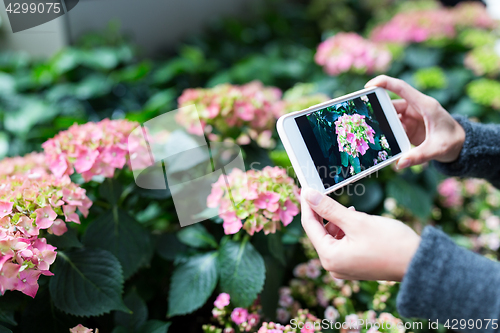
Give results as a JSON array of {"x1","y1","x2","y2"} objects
[{"x1": 370, "y1": 8, "x2": 455, "y2": 44}]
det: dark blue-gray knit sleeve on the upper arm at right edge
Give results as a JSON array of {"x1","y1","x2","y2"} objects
[{"x1": 435, "y1": 116, "x2": 500, "y2": 188}]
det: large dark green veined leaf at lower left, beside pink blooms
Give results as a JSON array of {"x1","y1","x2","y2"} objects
[{"x1": 49, "y1": 249, "x2": 129, "y2": 316}]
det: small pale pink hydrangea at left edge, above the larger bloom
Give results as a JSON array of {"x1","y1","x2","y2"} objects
[{"x1": 0, "y1": 153, "x2": 50, "y2": 177}]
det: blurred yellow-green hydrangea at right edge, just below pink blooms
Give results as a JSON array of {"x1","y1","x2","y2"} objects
[{"x1": 464, "y1": 46, "x2": 500, "y2": 76}]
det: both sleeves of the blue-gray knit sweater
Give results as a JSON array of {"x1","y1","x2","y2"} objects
[{"x1": 397, "y1": 117, "x2": 500, "y2": 332}]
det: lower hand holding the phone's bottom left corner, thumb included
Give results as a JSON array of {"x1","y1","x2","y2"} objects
[{"x1": 302, "y1": 189, "x2": 420, "y2": 281}]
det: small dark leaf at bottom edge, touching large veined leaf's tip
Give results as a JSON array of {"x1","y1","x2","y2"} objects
[{"x1": 115, "y1": 291, "x2": 148, "y2": 332}]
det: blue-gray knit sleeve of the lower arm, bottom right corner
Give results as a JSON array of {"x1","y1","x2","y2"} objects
[{"x1": 397, "y1": 227, "x2": 500, "y2": 332}]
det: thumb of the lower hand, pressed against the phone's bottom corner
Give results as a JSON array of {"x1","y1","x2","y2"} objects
[{"x1": 304, "y1": 188, "x2": 358, "y2": 232}]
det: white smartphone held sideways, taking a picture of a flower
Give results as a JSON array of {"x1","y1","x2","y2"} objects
[{"x1": 277, "y1": 87, "x2": 411, "y2": 193}]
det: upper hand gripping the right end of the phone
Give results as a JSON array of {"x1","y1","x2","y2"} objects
[{"x1": 365, "y1": 75, "x2": 465, "y2": 169}]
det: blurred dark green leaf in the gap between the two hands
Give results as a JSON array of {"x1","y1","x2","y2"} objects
[{"x1": 387, "y1": 178, "x2": 432, "y2": 220}]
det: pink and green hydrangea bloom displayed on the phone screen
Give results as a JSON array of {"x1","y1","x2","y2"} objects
[{"x1": 335, "y1": 114, "x2": 375, "y2": 157}]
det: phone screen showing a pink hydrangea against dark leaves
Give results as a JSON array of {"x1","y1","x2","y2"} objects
[{"x1": 295, "y1": 93, "x2": 401, "y2": 189}]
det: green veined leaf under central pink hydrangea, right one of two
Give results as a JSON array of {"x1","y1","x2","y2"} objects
[{"x1": 219, "y1": 239, "x2": 266, "y2": 307}]
